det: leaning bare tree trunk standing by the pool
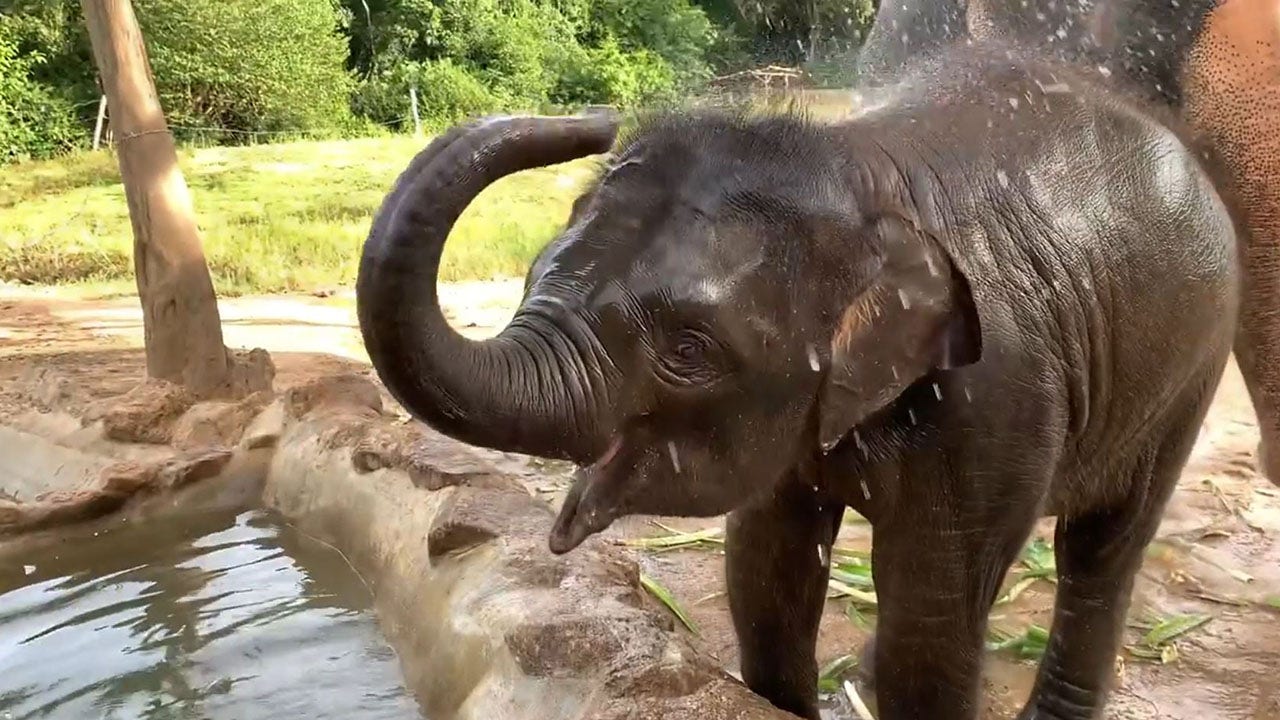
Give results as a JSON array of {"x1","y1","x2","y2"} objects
[{"x1": 81, "y1": 0, "x2": 232, "y2": 397}]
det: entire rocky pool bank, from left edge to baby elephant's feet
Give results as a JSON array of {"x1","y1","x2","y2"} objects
[{"x1": 0, "y1": 373, "x2": 791, "y2": 720}]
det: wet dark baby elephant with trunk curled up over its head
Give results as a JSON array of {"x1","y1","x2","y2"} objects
[{"x1": 357, "y1": 45, "x2": 1239, "y2": 720}]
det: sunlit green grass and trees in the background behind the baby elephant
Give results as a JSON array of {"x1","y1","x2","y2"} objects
[{"x1": 0, "y1": 0, "x2": 873, "y2": 295}]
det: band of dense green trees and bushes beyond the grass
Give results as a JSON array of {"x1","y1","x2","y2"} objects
[{"x1": 0, "y1": 0, "x2": 874, "y2": 160}]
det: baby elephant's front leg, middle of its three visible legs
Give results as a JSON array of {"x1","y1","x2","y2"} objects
[{"x1": 872, "y1": 491, "x2": 1042, "y2": 720}]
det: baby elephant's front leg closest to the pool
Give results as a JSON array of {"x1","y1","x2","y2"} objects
[{"x1": 724, "y1": 477, "x2": 845, "y2": 720}]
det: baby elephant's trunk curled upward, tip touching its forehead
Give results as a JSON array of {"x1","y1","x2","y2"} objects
[{"x1": 356, "y1": 115, "x2": 617, "y2": 460}]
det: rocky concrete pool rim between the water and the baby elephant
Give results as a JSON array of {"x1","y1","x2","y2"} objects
[{"x1": 264, "y1": 368, "x2": 791, "y2": 720}]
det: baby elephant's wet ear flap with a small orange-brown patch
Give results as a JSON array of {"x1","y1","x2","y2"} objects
[{"x1": 819, "y1": 211, "x2": 982, "y2": 451}]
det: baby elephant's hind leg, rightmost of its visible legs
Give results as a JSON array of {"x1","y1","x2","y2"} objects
[{"x1": 1019, "y1": 394, "x2": 1213, "y2": 720}]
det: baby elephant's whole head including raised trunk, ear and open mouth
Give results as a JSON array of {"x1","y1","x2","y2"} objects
[{"x1": 357, "y1": 110, "x2": 980, "y2": 552}]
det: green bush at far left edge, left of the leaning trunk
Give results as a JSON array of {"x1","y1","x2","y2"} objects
[{"x1": 0, "y1": 15, "x2": 83, "y2": 163}]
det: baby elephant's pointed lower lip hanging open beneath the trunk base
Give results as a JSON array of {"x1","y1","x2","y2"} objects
[{"x1": 548, "y1": 434, "x2": 626, "y2": 555}]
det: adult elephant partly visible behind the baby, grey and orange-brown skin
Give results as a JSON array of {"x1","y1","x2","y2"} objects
[{"x1": 859, "y1": 0, "x2": 1280, "y2": 484}]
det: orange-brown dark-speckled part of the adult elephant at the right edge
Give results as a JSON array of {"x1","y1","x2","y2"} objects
[{"x1": 1185, "y1": 0, "x2": 1280, "y2": 484}]
